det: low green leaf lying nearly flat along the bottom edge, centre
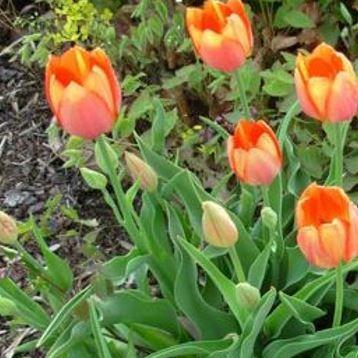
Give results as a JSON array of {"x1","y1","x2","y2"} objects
[{"x1": 147, "y1": 336, "x2": 236, "y2": 358}]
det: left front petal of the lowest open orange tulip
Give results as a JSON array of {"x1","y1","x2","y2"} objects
[{"x1": 297, "y1": 226, "x2": 335, "y2": 268}]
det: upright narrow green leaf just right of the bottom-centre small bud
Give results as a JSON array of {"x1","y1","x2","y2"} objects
[{"x1": 240, "y1": 288, "x2": 276, "y2": 357}]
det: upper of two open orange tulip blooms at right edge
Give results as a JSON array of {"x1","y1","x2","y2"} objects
[{"x1": 295, "y1": 43, "x2": 358, "y2": 122}]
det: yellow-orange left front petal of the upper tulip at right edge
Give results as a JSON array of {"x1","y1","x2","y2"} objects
[{"x1": 307, "y1": 77, "x2": 332, "y2": 120}]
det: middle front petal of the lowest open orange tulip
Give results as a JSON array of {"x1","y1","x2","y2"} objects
[{"x1": 318, "y1": 219, "x2": 347, "y2": 266}]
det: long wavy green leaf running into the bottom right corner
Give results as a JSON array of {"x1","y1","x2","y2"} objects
[{"x1": 263, "y1": 318, "x2": 358, "y2": 358}]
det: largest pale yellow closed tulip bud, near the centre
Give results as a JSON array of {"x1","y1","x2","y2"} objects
[{"x1": 202, "y1": 201, "x2": 239, "y2": 247}]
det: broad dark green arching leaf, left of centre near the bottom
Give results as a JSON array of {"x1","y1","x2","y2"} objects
[{"x1": 98, "y1": 290, "x2": 180, "y2": 337}]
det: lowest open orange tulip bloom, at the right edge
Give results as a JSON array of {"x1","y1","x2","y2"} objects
[{"x1": 296, "y1": 183, "x2": 358, "y2": 268}]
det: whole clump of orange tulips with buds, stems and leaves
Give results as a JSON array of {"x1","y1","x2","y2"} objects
[{"x1": 0, "y1": 0, "x2": 358, "y2": 358}]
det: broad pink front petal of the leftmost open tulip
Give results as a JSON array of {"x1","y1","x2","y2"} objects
[{"x1": 57, "y1": 82, "x2": 115, "y2": 139}]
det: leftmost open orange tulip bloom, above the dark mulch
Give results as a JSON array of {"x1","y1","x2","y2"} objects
[{"x1": 45, "y1": 46, "x2": 121, "y2": 139}]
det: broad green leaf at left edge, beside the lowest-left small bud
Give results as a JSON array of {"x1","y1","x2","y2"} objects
[{"x1": 0, "y1": 278, "x2": 50, "y2": 331}]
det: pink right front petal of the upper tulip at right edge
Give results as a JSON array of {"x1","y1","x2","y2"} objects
[{"x1": 327, "y1": 72, "x2": 358, "y2": 122}]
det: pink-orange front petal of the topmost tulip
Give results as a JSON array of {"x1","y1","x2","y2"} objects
[{"x1": 198, "y1": 30, "x2": 246, "y2": 72}]
